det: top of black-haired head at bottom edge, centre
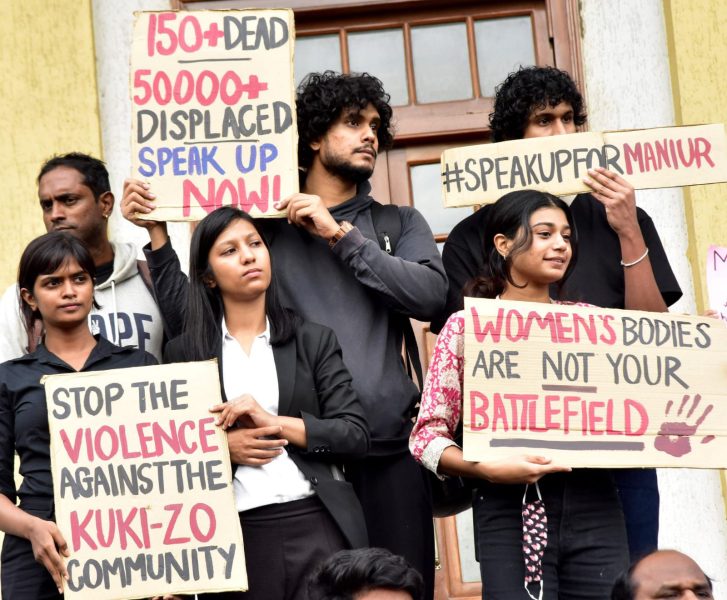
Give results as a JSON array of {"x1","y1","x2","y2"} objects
[{"x1": 308, "y1": 548, "x2": 424, "y2": 600}]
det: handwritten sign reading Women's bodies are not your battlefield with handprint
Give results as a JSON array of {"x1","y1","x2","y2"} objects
[{"x1": 463, "y1": 298, "x2": 727, "y2": 468}]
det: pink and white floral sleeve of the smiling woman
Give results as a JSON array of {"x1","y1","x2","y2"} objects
[{"x1": 409, "y1": 311, "x2": 464, "y2": 473}]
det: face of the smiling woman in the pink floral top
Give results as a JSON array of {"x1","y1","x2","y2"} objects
[{"x1": 504, "y1": 206, "x2": 571, "y2": 286}]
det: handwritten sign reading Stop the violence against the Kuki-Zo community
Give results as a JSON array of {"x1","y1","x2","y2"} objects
[{"x1": 44, "y1": 361, "x2": 247, "y2": 600}]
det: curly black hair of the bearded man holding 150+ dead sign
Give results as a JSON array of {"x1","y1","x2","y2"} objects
[{"x1": 296, "y1": 71, "x2": 394, "y2": 169}]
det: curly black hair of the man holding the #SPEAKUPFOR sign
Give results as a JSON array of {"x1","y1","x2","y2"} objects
[{"x1": 490, "y1": 67, "x2": 586, "y2": 142}]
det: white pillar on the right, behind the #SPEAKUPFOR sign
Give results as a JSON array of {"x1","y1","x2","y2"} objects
[{"x1": 581, "y1": 0, "x2": 727, "y2": 598}]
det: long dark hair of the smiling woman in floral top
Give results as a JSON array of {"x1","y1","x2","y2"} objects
[{"x1": 464, "y1": 190, "x2": 578, "y2": 298}]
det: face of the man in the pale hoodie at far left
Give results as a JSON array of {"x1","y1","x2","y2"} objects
[{"x1": 38, "y1": 167, "x2": 114, "y2": 247}]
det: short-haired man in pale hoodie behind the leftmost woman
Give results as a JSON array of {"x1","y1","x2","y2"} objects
[{"x1": 0, "y1": 152, "x2": 164, "y2": 362}]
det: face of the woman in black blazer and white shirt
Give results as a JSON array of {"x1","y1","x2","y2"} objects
[{"x1": 207, "y1": 219, "x2": 271, "y2": 302}]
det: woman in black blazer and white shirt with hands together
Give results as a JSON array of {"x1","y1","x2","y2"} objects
[{"x1": 164, "y1": 207, "x2": 369, "y2": 600}]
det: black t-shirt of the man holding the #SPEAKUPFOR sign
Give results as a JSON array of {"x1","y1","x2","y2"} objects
[{"x1": 431, "y1": 194, "x2": 682, "y2": 333}]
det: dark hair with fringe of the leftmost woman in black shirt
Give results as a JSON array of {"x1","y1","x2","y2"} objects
[{"x1": 18, "y1": 231, "x2": 98, "y2": 332}]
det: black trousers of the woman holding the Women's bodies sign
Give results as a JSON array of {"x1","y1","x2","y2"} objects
[{"x1": 473, "y1": 469, "x2": 629, "y2": 600}]
